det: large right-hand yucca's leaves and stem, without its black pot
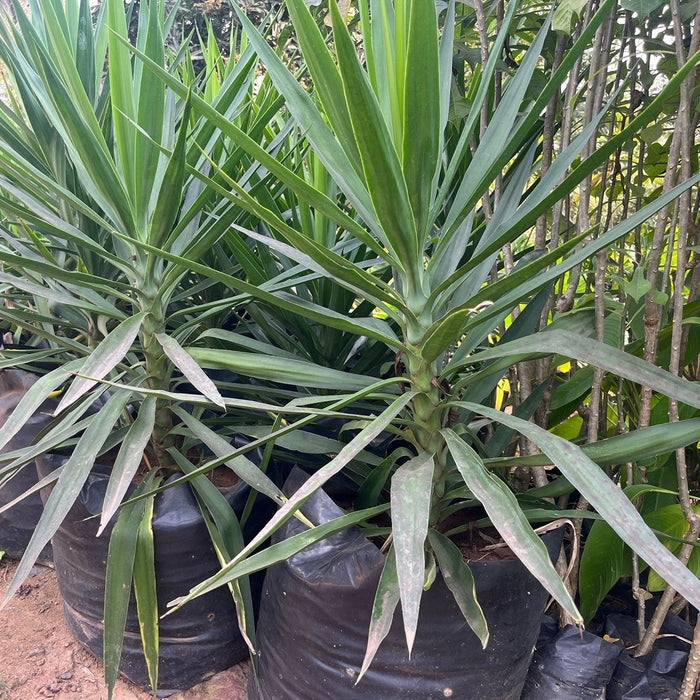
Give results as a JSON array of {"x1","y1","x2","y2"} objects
[{"x1": 157, "y1": 0, "x2": 700, "y2": 672}]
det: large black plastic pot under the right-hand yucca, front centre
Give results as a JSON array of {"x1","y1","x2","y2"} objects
[{"x1": 248, "y1": 470, "x2": 561, "y2": 700}]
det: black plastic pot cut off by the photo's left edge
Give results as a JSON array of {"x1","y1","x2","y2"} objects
[{"x1": 0, "y1": 369, "x2": 58, "y2": 564}]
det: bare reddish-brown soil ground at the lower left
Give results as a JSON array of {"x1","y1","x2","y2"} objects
[{"x1": 0, "y1": 559, "x2": 248, "y2": 700}]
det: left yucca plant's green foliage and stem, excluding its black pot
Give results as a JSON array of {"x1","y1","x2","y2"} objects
[{"x1": 0, "y1": 0, "x2": 318, "y2": 689}]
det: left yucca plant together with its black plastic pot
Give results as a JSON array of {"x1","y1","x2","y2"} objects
[{"x1": 0, "y1": 0, "x2": 314, "y2": 691}]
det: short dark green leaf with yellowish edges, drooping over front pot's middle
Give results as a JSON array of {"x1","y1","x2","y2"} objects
[{"x1": 428, "y1": 529, "x2": 489, "y2": 649}]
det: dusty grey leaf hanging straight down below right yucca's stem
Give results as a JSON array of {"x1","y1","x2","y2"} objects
[{"x1": 391, "y1": 453, "x2": 435, "y2": 658}]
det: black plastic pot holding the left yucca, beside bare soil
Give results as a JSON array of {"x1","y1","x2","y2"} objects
[{"x1": 37, "y1": 455, "x2": 267, "y2": 696}]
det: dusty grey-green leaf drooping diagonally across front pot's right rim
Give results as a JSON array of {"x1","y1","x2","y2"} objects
[{"x1": 442, "y1": 430, "x2": 580, "y2": 620}]
